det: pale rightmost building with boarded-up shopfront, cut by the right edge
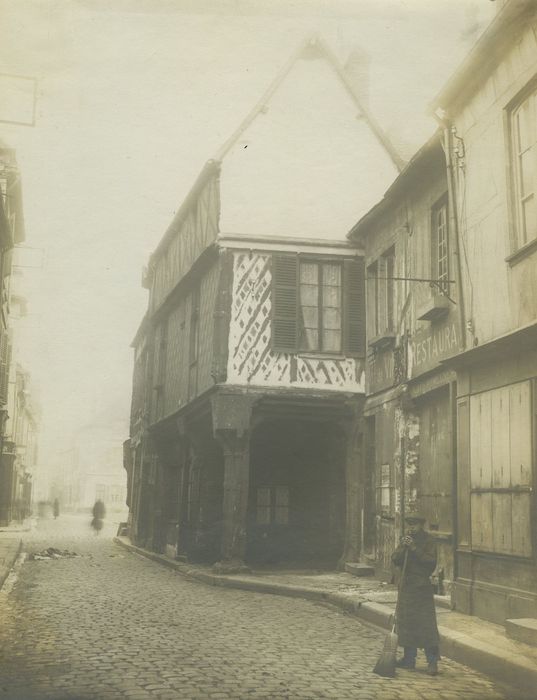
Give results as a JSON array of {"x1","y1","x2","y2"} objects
[{"x1": 434, "y1": 0, "x2": 537, "y2": 622}]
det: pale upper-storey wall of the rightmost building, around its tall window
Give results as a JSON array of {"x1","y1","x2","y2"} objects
[{"x1": 453, "y1": 21, "x2": 537, "y2": 345}]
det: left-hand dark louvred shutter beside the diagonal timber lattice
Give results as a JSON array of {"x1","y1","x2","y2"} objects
[{"x1": 272, "y1": 255, "x2": 298, "y2": 352}]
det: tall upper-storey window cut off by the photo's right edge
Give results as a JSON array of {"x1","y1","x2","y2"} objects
[{"x1": 512, "y1": 91, "x2": 537, "y2": 248}]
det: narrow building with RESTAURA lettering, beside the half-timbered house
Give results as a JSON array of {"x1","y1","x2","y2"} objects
[{"x1": 349, "y1": 131, "x2": 461, "y2": 593}]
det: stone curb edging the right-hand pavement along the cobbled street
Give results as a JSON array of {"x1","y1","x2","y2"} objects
[{"x1": 114, "y1": 537, "x2": 537, "y2": 698}]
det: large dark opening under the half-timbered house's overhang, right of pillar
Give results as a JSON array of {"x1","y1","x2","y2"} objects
[{"x1": 247, "y1": 420, "x2": 345, "y2": 568}]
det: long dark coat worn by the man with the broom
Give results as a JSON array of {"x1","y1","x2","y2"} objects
[{"x1": 392, "y1": 530, "x2": 438, "y2": 649}]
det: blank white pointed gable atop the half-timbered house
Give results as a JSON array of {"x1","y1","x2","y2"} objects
[{"x1": 216, "y1": 39, "x2": 401, "y2": 246}]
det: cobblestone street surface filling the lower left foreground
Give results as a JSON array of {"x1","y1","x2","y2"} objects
[{"x1": 0, "y1": 516, "x2": 516, "y2": 700}]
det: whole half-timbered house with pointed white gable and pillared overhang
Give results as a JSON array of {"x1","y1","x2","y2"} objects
[{"x1": 125, "y1": 39, "x2": 399, "y2": 571}]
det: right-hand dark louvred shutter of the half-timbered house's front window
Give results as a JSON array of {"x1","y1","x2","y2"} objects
[{"x1": 343, "y1": 258, "x2": 365, "y2": 357}]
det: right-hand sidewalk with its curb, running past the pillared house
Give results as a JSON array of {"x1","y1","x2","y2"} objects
[{"x1": 115, "y1": 537, "x2": 537, "y2": 698}]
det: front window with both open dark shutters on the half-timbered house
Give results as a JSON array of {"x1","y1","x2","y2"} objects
[{"x1": 272, "y1": 255, "x2": 365, "y2": 355}]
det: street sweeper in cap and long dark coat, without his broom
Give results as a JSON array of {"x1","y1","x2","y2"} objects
[{"x1": 392, "y1": 513, "x2": 440, "y2": 676}]
